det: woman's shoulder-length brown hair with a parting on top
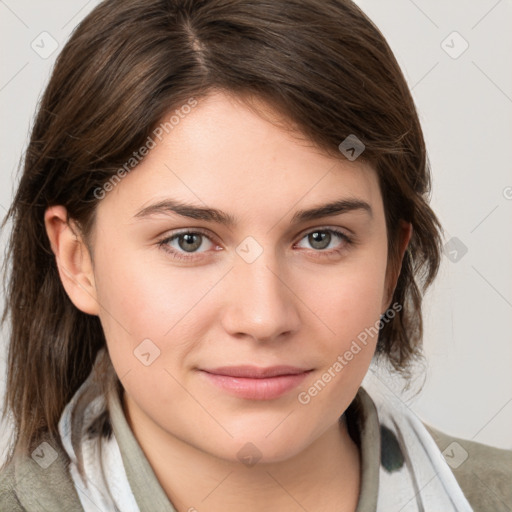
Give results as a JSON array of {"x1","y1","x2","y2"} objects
[{"x1": 2, "y1": 0, "x2": 441, "y2": 466}]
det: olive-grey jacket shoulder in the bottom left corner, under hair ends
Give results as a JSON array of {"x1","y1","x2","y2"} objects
[{"x1": 0, "y1": 435, "x2": 83, "y2": 512}]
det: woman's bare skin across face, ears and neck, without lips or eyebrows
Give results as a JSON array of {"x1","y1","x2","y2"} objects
[{"x1": 45, "y1": 92, "x2": 411, "y2": 512}]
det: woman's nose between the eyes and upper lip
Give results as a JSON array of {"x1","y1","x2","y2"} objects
[{"x1": 222, "y1": 251, "x2": 300, "y2": 342}]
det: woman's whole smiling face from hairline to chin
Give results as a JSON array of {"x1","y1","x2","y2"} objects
[{"x1": 92, "y1": 93, "x2": 388, "y2": 462}]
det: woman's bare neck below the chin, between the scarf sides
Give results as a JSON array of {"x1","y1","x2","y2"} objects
[{"x1": 123, "y1": 393, "x2": 361, "y2": 512}]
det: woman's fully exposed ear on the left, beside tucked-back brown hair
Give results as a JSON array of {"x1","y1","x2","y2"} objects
[{"x1": 44, "y1": 206, "x2": 100, "y2": 315}]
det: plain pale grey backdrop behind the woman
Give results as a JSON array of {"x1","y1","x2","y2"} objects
[{"x1": 0, "y1": 0, "x2": 512, "y2": 464}]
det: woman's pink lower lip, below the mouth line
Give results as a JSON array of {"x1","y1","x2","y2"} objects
[{"x1": 201, "y1": 371, "x2": 309, "y2": 400}]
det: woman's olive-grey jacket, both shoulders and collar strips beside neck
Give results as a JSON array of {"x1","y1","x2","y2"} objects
[{"x1": 0, "y1": 386, "x2": 512, "y2": 512}]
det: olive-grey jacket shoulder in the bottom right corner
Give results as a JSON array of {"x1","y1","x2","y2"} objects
[{"x1": 423, "y1": 423, "x2": 512, "y2": 512}]
